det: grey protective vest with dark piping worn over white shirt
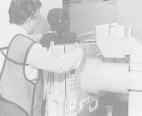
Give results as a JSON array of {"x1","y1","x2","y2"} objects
[{"x1": 0, "y1": 34, "x2": 43, "y2": 116}]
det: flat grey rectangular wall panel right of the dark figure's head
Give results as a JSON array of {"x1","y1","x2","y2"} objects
[{"x1": 69, "y1": 1, "x2": 117, "y2": 34}]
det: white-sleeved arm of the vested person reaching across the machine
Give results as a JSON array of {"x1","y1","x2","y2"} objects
[{"x1": 27, "y1": 43, "x2": 84, "y2": 73}]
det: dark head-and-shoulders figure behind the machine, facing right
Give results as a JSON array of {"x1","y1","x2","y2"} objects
[{"x1": 40, "y1": 8, "x2": 76, "y2": 48}]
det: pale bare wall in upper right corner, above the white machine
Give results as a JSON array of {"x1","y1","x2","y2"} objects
[{"x1": 117, "y1": 0, "x2": 142, "y2": 39}]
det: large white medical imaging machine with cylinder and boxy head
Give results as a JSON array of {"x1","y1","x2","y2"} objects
[{"x1": 46, "y1": 23, "x2": 142, "y2": 116}]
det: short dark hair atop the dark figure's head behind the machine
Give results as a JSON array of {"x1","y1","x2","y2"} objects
[{"x1": 47, "y1": 8, "x2": 67, "y2": 24}]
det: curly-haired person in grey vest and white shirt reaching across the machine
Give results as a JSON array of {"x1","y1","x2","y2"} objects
[{"x1": 0, "y1": 0, "x2": 84, "y2": 116}]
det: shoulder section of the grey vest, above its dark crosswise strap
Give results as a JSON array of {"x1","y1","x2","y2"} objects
[{"x1": 6, "y1": 34, "x2": 36, "y2": 65}]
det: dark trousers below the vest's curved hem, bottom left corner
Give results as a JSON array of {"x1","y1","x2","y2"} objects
[{"x1": 0, "y1": 100, "x2": 27, "y2": 116}]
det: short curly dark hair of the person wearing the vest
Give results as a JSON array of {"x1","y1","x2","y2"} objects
[{"x1": 9, "y1": 0, "x2": 41, "y2": 25}]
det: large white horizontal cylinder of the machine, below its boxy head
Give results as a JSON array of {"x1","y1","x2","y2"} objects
[{"x1": 80, "y1": 58, "x2": 129, "y2": 94}]
